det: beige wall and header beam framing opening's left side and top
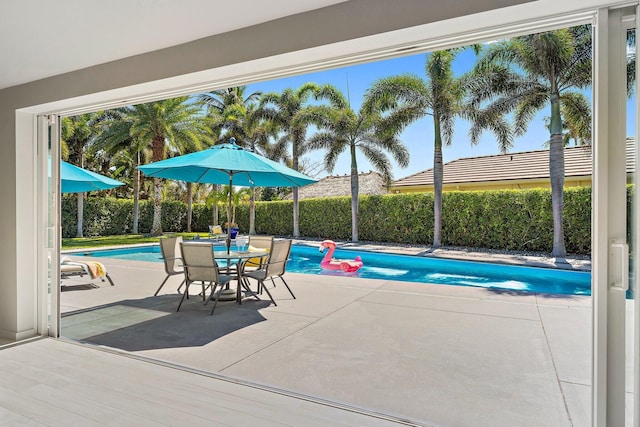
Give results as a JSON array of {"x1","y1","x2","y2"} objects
[{"x1": 0, "y1": 0, "x2": 620, "y2": 339}]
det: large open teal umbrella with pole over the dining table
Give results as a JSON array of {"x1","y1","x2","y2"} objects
[{"x1": 138, "y1": 138, "x2": 316, "y2": 251}]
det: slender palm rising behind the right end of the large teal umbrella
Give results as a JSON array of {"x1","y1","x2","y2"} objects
[{"x1": 256, "y1": 83, "x2": 318, "y2": 237}]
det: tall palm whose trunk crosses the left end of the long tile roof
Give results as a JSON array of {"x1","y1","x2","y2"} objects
[{"x1": 366, "y1": 46, "x2": 479, "y2": 247}]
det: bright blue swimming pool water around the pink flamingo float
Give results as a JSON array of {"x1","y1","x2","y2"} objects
[{"x1": 72, "y1": 245, "x2": 591, "y2": 295}]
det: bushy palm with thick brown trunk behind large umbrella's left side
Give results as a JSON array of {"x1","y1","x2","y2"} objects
[{"x1": 100, "y1": 97, "x2": 210, "y2": 236}]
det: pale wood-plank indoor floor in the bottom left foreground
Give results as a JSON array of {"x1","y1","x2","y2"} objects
[{"x1": 0, "y1": 339, "x2": 415, "y2": 426}]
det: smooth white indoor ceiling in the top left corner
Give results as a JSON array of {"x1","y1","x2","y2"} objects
[{"x1": 0, "y1": 0, "x2": 345, "y2": 89}]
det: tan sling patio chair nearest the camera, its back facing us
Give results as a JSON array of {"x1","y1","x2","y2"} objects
[{"x1": 176, "y1": 242, "x2": 232, "y2": 314}]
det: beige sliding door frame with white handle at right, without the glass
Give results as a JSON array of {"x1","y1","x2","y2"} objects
[{"x1": 591, "y1": 6, "x2": 638, "y2": 426}]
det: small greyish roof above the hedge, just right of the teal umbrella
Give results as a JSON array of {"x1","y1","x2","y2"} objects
[{"x1": 287, "y1": 172, "x2": 389, "y2": 200}]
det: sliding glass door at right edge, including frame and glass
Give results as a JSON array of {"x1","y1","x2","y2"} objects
[{"x1": 592, "y1": 7, "x2": 640, "y2": 427}]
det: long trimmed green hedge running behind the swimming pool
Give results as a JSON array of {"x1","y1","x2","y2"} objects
[{"x1": 62, "y1": 187, "x2": 608, "y2": 254}]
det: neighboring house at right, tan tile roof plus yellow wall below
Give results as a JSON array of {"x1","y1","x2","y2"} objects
[{"x1": 391, "y1": 138, "x2": 635, "y2": 193}]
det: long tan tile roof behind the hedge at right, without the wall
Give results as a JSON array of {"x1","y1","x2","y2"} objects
[{"x1": 392, "y1": 138, "x2": 635, "y2": 187}]
